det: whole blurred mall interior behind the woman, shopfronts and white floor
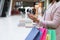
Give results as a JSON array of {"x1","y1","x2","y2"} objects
[{"x1": 0, "y1": 0, "x2": 60, "y2": 40}]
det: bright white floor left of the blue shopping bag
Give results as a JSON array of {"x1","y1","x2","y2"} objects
[{"x1": 0, "y1": 15, "x2": 31, "y2": 40}]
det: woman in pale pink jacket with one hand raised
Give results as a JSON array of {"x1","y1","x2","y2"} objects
[{"x1": 28, "y1": 0, "x2": 60, "y2": 40}]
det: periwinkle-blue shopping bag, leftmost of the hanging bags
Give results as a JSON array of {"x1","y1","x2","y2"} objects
[{"x1": 25, "y1": 27, "x2": 39, "y2": 40}]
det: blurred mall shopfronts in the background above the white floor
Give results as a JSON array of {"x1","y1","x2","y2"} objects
[{"x1": 0, "y1": 0, "x2": 49, "y2": 17}]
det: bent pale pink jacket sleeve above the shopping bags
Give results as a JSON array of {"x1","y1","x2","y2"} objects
[{"x1": 39, "y1": 7, "x2": 60, "y2": 28}]
